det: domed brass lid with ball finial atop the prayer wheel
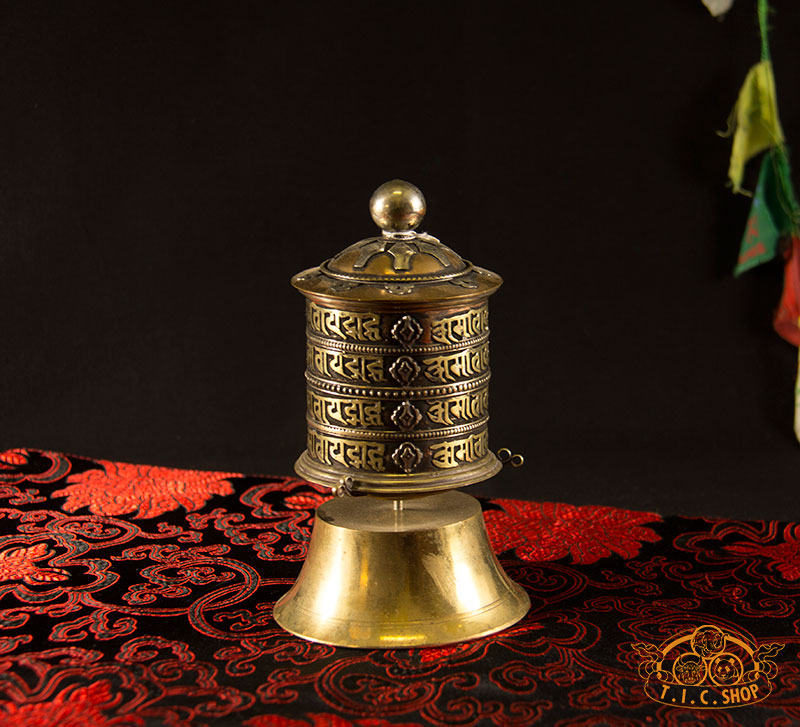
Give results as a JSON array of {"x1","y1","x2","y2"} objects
[{"x1": 292, "y1": 179, "x2": 502, "y2": 303}]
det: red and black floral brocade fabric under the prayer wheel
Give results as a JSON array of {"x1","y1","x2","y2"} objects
[{"x1": 0, "y1": 450, "x2": 800, "y2": 727}]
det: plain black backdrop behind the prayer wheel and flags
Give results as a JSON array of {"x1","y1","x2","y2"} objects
[{"x1": 0, "y1": 0, "x2": 800, "y2": 519}]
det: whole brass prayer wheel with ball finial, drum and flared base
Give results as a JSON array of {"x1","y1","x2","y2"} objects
[{"x1": 275, "y1": 180, "x2": 529, "y2": 647}]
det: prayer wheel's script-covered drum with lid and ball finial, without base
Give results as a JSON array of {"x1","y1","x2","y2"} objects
[{"x1": 292, "y1": 180, "x2": 502, "y2": 495}]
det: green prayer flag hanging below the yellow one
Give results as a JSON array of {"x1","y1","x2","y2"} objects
[{"x1": 733, "y1": 147, "x2": 798, "y2": 276}]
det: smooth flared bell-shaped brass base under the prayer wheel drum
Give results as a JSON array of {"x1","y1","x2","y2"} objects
[{"x1": 274, "y1": 491, "x2": 530, "y2": 649}]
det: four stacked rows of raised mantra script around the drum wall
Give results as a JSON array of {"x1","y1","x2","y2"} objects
[{"x1": 306, "y1": 301, "x2": 490, "y2": 474}]
